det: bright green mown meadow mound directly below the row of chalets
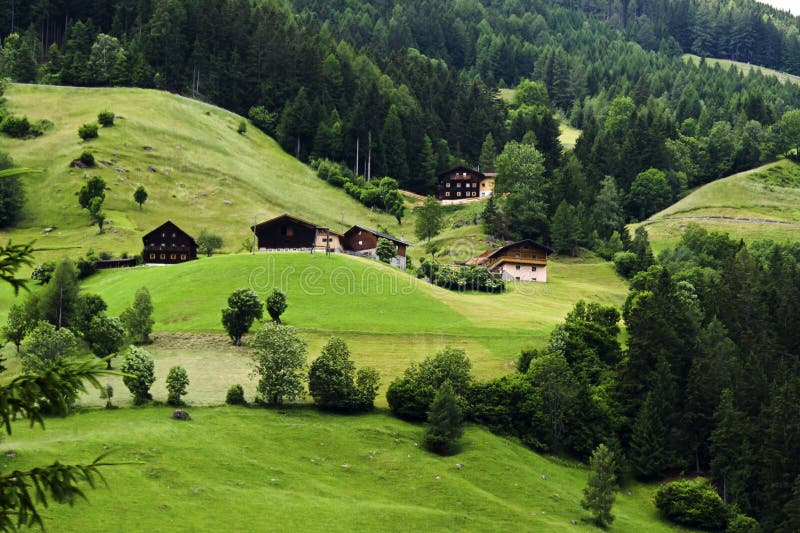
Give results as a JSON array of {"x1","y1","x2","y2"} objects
[{"x1": 0, "y1": 253, "x2": 627, "y2": 405}]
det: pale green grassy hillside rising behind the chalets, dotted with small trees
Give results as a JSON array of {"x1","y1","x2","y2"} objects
[{"x1": 0, "y1": 85, "x2": 404, "y2": 256}]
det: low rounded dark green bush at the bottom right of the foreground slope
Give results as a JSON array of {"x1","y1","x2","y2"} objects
[{"x1": 656, "y1": 478, "x2": 728, "y2": 529}]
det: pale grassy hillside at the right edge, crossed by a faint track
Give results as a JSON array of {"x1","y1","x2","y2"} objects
[{"x1": 644, "y1": 160, "x2": 800, "y2": 249}]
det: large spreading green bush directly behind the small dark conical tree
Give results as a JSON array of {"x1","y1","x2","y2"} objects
[{"x1": 386, "y1": 348, "x2": 472, "y2": 421}]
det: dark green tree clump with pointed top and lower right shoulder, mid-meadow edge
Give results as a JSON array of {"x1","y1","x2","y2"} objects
[{"x1": 308, "y1": 337, "x2": 380, "y2": 412}]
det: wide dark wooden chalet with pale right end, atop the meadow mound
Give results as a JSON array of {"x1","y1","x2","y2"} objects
[{"x1": 250, "y1": 214, "x2": 344, "y2": 252}]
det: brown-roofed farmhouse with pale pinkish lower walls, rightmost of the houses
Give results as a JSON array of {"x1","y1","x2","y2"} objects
[{"x1": 467, "y1": 239, "x2": 553, "y2": 283}]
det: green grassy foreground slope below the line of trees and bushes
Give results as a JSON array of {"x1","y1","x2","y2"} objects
[{"x1": 2, "y1": 407, "x2": 672, "y2": 532}]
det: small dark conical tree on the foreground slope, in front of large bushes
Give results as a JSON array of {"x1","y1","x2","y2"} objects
[{"x1": 422, "y1": 381, "x2": 464, "y2": 455}]
